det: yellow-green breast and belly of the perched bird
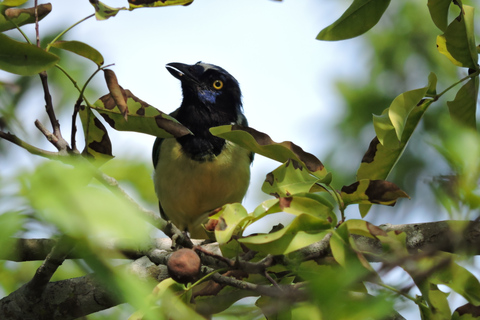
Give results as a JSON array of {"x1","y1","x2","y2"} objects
[{"x1": 153, "y1": 139, "x2": 250, "y2": 238}]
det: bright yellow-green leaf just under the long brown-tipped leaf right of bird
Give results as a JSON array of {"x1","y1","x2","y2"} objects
[{"x1": 262, "y1": 159, "x2": 324, "y2": 198}]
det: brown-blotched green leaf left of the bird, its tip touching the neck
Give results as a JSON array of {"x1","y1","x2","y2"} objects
[{"x1": 92, "y1": 88, "x2": 191, "y2": 138}]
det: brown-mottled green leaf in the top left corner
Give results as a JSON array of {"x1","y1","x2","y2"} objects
[{"x1": 0, "y1": 2, "x2": 52, "y2": 32}]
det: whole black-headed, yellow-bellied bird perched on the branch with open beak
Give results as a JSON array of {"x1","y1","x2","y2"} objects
[{"x1": 152, "y1": 62, "x2": 253, "y2": 239}]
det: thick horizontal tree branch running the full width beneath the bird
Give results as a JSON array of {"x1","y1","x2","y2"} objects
[{"x1": 0, "y1": 220, "x2": 480, "y2": 262}]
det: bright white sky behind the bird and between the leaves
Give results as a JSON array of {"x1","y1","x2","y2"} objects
[{"x1": 0, "y1": 0, "x2": 456, "y2": 319}]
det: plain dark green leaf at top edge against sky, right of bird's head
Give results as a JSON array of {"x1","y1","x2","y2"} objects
[{"x1": 317, "y1": 0, "x2": 390, "y2": 41}]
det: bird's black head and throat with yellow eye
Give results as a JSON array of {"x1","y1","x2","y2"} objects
[{"x1": 166, "y1": 62, "x2": 246, "y2": 158}]
